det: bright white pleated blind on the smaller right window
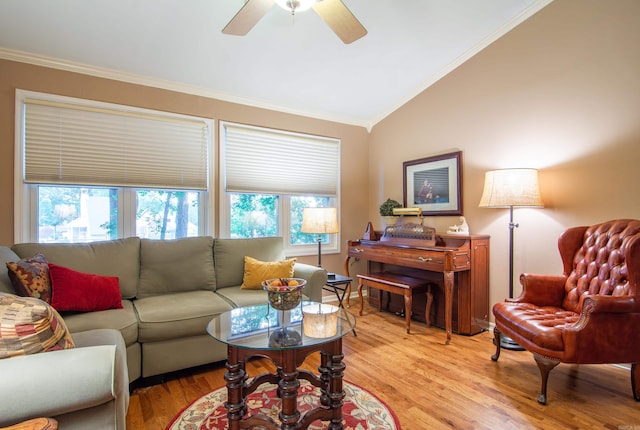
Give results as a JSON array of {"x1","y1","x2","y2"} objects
[{"x1": 221, "y1": 123, "x2": 340, "y2": 197}]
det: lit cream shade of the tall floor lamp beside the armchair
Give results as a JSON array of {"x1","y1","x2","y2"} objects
[{"x1": 479, "y1": 169, "x2": 544, "y2": 208}]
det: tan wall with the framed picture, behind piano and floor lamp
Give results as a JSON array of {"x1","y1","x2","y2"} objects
[{"x1": 369, "y1": 0, "x2": 640, "y2": 310}]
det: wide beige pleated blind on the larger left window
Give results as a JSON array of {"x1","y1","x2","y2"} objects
[{"x1": 23, "y1": 98, "x2": 210, "y2": 190}]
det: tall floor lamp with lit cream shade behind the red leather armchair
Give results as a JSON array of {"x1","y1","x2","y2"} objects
[{"x1": 479, "y1": 169, "x2": 543, "y2": 351}]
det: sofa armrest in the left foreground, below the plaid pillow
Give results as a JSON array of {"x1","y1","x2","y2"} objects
[{"x1": 0, "y1": 345, "x2": 116, "y2": 425}]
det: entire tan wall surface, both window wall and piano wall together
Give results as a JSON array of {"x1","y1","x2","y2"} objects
[{"x1": 0, "y1": 0, "x2": 640, "y2": 310}]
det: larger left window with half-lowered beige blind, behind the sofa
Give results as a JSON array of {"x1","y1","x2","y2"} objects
[{"x1": 15, "y1": 90, "x2": 211, "y2": 242}]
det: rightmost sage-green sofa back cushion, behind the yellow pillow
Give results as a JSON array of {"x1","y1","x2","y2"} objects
[{"x1": 213, "y1": 237, "x2": 285, "y2": 288}]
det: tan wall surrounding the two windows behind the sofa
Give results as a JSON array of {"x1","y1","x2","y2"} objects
[{"x1": 0, "y1": 60, "x2": 369, "y2": 273}]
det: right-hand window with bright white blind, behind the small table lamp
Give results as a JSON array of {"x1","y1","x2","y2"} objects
[{"x1": 220, "y1": 123, "x2": 340, "y2": 255}]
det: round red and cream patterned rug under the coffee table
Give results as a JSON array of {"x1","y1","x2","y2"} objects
[{"x1": 166, "y1": 381, "x2": 400, "y2": 430}]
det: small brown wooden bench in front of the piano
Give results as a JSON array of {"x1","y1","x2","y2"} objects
[{"x1": 358, "y1": 272, "x2": 433, "y2": 334}]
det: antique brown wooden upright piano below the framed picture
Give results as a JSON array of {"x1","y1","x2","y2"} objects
[{"x1": 345, "y1": 223, "x2": 489, "y2": 343}]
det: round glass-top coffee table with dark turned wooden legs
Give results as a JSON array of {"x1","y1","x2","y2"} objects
[{"x1": 207, "y1": 301, "x2": 356, "y2": 430}]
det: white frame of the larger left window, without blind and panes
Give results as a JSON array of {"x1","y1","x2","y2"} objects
[{"x1": 14, "y1": 89, "x2": 216, "y2": 243}]
